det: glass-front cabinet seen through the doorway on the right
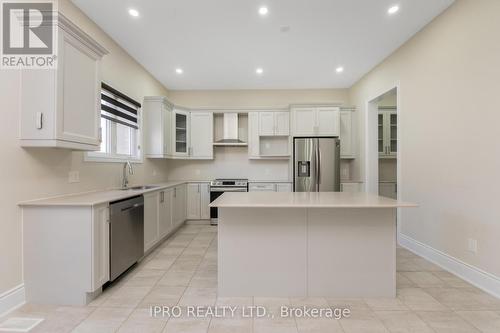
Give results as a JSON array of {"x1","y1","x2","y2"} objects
[{"x1": 378, "y1": 108, "x2": 398, "y2": 158}]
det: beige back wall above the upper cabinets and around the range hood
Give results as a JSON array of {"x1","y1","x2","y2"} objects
[{"x1": 168, "y1": 89, "x2": 348, "y2": 181}]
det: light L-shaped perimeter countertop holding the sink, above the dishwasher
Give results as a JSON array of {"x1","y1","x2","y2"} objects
[{"x1": 19, "y1": 180, "x2": 188, "y2": 206}]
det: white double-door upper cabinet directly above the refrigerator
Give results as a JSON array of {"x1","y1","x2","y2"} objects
[{"x1": 292, "y1": 107, "x2": 340, "y2": 136}]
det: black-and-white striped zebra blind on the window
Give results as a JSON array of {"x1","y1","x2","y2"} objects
[{"x1": 101, "y1": 83, "x2": 141, "y2": 129}]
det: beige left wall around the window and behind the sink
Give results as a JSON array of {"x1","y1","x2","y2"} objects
[{"x1": 0, "y1": 0, "x2": 172, "y2": 294}]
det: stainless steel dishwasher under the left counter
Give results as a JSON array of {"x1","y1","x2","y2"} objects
[{"x1": 109, "y1": 195, "x2": 144, "y2": 281}]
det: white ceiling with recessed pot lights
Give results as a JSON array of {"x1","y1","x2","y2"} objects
[{"x1": 72, "y1": 0, "x2": 453, "y2": 89}]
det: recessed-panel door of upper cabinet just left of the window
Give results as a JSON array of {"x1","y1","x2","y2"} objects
[{"x1": 56, "y1": 29, "x2": 101, "y2": 146}]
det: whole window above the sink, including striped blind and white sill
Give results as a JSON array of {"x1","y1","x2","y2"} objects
[{"x1": 85, "y1": 83, "x2": 142, "y2": 162}]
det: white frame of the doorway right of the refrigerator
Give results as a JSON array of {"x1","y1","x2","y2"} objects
[{"x1": 364, "y1": 81, "x2": 403, "y2": 227}]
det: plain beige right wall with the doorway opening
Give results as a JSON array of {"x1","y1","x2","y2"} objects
[{"x1": 350, "y1": 0, "x2": 500, "y2": 276}]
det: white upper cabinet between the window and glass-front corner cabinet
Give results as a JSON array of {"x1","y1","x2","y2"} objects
[{"x1": 142, "y1": 96, "x2": 172, "y2": 158}]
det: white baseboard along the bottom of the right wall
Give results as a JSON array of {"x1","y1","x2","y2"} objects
[{"x1": 398, "y1": 234, "x2": 500, "y2": 298}]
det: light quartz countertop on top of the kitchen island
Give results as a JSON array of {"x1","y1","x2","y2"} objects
[{"x1": 210, "y1": 192, "x2": 417, "y2": 208}]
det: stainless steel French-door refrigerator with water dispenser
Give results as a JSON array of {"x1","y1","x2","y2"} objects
[{"x1": 293, "y1": 138, "x2": 340, "y2": 192}]
